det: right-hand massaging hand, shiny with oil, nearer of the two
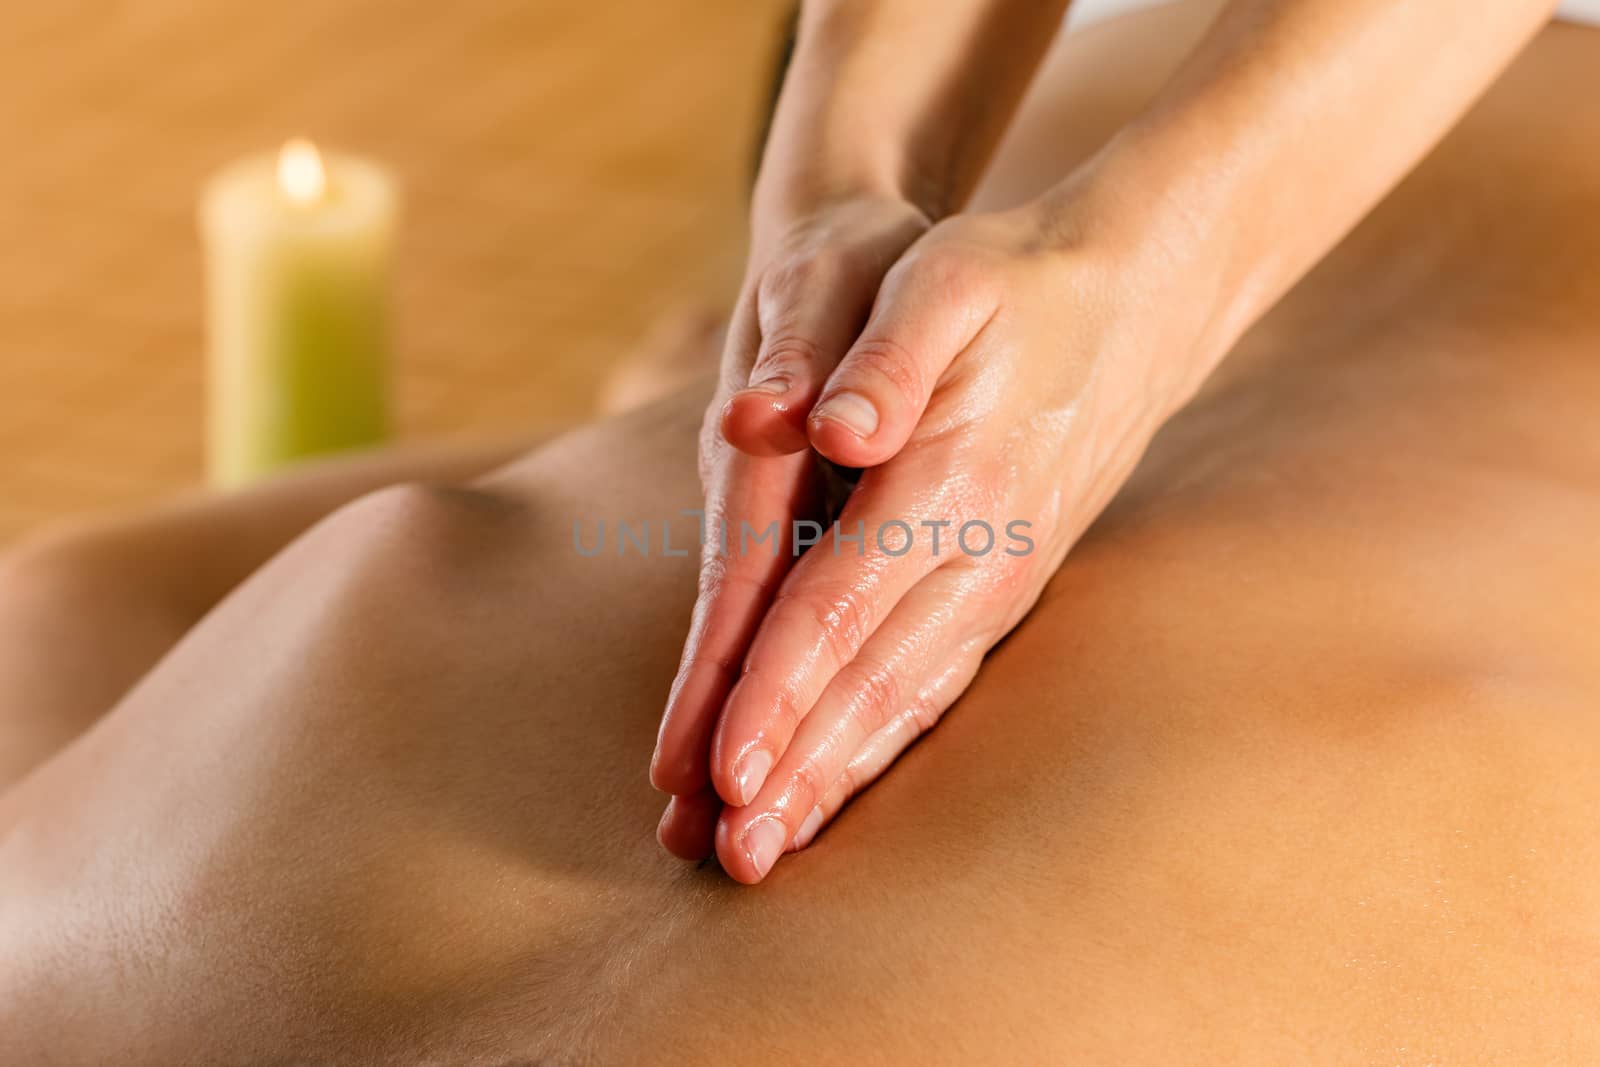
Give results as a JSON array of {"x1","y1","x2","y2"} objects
[{"x1": 694, "y1": 197, "x2": 1203, "y2": 881}]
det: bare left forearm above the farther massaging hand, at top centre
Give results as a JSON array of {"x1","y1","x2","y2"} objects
[{"x1": 755, "y1": 0, "x2": 1067, "y2": 231}]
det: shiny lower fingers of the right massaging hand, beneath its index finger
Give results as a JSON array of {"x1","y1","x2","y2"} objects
[{"x1": 717, "y1": 565, "x2": 987, "y2": 883}]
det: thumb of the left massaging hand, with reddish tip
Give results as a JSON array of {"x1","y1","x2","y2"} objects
[{"x1": 722, "y1": 258, "x2": 877, "y2": 456}]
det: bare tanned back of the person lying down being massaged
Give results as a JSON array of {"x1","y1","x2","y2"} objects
[{"x1": 0, "y1": 11, "x2": 1600, "y2": 1064}]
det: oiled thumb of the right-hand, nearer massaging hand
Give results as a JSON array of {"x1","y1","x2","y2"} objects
[{"x1": 808, "y1": 256, "x2": 995, "y2": 467}]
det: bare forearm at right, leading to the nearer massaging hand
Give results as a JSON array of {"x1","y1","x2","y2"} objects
[{"x1": 1046, "y1": 0, "x2": 1555, "y2": 392}]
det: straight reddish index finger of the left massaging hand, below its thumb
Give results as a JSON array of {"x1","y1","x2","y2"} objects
[{"x1": 650, "y1": 450, "x2": 816, "y2": 795}]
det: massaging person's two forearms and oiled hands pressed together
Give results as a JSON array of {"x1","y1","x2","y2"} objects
[{"x1": 653, "y1": 0, "x2": 1574, "y2": 881}]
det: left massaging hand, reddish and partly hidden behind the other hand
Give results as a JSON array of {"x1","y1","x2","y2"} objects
[{"x1": 650, "y1": 195, "x2": 930, "y2": 859}]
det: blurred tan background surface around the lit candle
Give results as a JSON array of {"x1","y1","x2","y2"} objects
[{"x1": 0, "y1": 0, "x2": 787, "y2": 539}]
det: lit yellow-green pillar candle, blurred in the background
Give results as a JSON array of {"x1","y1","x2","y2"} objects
[{"x1": 200, "y1": 141, "x2": 398, "y2": 486}]
